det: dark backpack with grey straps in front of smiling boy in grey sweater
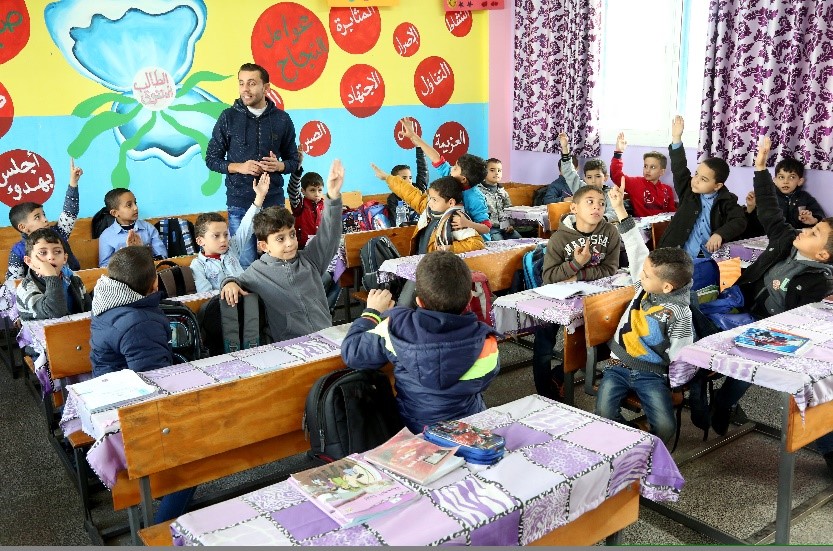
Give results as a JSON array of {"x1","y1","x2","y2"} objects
[{"x1": 197, "y1": 293, "x2": 272, "y2": 356}]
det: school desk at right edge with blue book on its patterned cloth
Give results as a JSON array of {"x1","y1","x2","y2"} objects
[{"x1": 669, "y1": 303, "x2": 833, "y2": 545}]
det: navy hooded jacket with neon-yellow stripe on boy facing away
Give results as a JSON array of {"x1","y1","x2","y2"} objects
[{"x1": 341, "y1": 308, "x2": 500, "y2": 433}]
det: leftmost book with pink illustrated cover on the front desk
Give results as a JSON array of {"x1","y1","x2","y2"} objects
[{"x1": 290, "y1": 457, "x2": 419, "y2": 527}]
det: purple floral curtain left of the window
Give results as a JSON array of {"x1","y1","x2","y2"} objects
[{"x1": 512, "y1": 0, "x2": 603, "y2": 157}]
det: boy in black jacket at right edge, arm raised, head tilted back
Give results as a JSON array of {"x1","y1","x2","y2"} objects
[{"x1": 711, "y1": 137, "x2": 833, "y2": 474}]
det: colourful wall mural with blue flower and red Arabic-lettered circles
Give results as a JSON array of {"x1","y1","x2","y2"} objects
[{"x1": 0, "y1": 0, "x2": 489, "y2": 225}]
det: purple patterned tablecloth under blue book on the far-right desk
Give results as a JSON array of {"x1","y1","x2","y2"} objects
[{"x1": 669, "y1": 303, "x2": 833, "y2": 414}]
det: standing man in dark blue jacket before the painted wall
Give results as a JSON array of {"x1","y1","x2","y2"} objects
[{"x1": 205, "y1": 63, "x2": 300, "y2": 268}]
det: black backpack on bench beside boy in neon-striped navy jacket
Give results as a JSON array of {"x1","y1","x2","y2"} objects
[{"x1": 302, "y1": 369, "x2": 405, "y2": 462}]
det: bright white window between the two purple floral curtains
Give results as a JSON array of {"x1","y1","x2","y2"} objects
[{"x1": 597, "y1": 0, "x2": 709, "y2": 146}]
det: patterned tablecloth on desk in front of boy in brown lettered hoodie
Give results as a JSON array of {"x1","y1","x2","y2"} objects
[{"x1": 494, "y1": 272, "x2": 631, "y2": 333}]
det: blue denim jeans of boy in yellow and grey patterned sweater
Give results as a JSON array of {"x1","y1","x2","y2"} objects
[{"x1": 596, "y1": 363, "x2": 677, "y2": 442}]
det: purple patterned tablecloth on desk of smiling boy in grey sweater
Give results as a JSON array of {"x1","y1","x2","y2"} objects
[{"x1": 60, "y1": 324, "x2": 349, "y2": 488}]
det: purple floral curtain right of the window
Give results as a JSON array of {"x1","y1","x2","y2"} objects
[{"x1": 700, "y1": 0, "x2": 833, "y2": 170}]
